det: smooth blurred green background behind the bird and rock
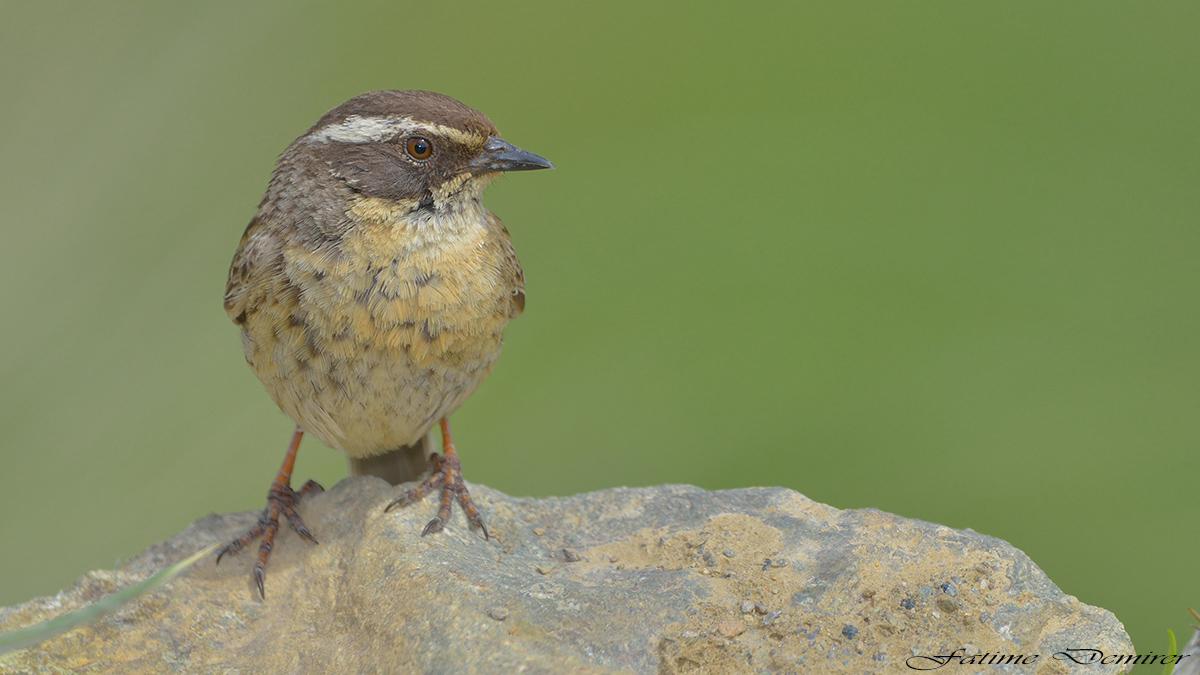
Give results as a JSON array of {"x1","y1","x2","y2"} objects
[{"x1": 0, "y1": 1, "x2": 1200, "y2": 652}]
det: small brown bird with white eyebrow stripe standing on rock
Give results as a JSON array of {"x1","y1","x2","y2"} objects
[{"x1": 217, "y1": 90, "x2": 553, "y2": 597}]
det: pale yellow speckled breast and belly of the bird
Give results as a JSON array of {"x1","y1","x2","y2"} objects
[{"x1": 245, "y1": 198, "x2": 523, "y2": 456}]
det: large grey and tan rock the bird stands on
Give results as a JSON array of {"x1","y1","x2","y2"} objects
[{"x1": 0, "y1": 477, "x2": 1134, "y2": 674}]
